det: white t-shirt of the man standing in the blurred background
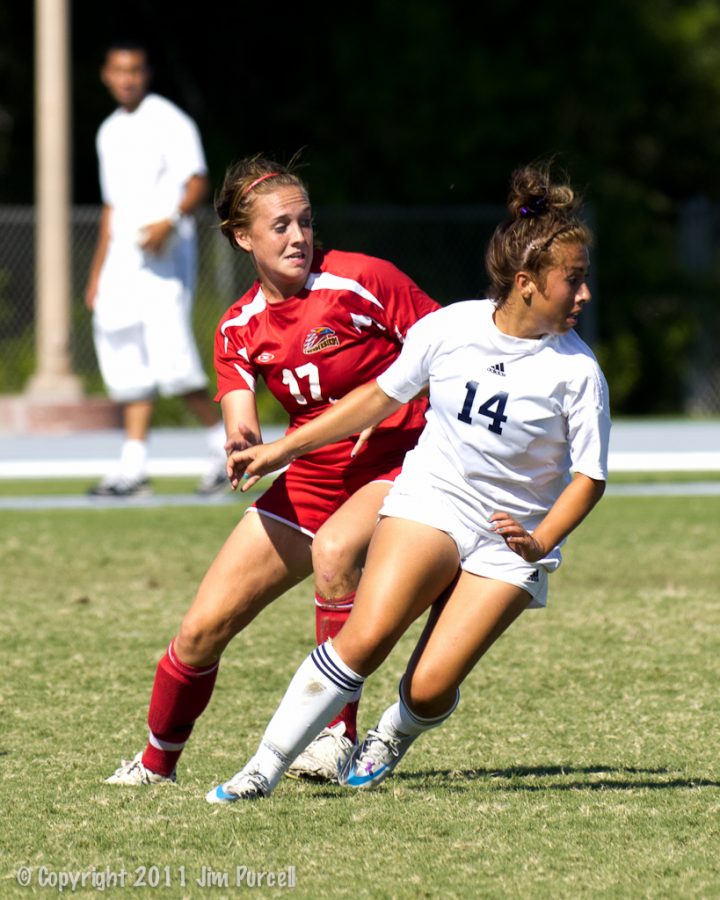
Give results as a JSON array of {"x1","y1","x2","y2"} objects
[{"x1": 95, "y1": 94, "x2": 207, "y2": 330}]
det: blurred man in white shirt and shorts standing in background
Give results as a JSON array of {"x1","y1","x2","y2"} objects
[{"x1": 85, "y1": 42, "x2": 227, "y2": 497}]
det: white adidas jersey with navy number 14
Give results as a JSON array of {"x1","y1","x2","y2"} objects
[{"x1": 377, "y1": 300, "x2": 610, "y2": 530}]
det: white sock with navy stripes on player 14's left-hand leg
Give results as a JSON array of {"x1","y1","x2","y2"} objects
[{"x1": 245, "y1": 641, "x2": 365, "y2": 790}]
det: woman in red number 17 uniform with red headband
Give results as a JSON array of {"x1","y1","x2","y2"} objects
[{"x1": 107, "y1": 156, "x2": 438, "y2": 784}]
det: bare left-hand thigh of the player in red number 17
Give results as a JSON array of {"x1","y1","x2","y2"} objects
[{"x1": 183, "y1": 511, "x2": 312, "y2": 639}]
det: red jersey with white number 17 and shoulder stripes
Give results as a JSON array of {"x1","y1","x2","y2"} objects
[{"x1": 215, "y1": 250, "x2": 439, "y2": 442}]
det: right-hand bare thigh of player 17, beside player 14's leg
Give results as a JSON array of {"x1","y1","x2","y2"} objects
[{"x1": 312, "y1": 481, "x2": 392, "y2": 590}]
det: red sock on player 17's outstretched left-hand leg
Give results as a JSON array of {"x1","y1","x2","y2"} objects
[{"x1": 142, "y1": 643, "x2": 220, "y2": 775}]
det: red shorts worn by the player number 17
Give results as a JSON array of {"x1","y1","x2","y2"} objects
[{"x1": 250, "y1": 427, "x2": 422, "y2": 537}]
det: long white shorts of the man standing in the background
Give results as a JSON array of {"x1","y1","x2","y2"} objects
[{"x1": 93, "y1": 303, "x2": 208, "y2": 403}]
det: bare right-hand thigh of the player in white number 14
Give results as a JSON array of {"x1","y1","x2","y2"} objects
[{"x1": 404, "y1": 572, "x2": 532, "y2": 715}]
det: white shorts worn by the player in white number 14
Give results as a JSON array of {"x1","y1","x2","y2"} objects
[{"x1": 380, "y1": 471, "x2": 560, "y2": 608}]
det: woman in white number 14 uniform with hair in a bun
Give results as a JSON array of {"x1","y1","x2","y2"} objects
[{"x1": 207, "y1": 166, "x2": 610, "y2": 803}]
